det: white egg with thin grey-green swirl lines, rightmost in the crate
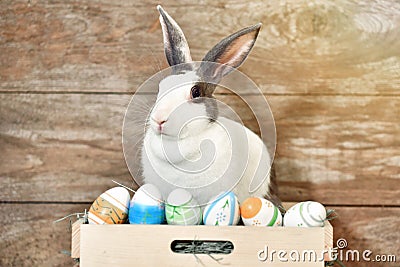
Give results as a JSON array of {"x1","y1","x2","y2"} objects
[{"x1": 283, "y1": 201, "x2": 326, "y2": 227}]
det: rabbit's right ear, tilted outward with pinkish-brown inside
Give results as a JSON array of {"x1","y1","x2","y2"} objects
[{"x1": 200, "y1": 23, "x2": 261, "y2": 81}]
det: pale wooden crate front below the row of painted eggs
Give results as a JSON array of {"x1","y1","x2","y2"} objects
[{"x1": 72, "y1": 222, "x2": 333, "y2": 267}]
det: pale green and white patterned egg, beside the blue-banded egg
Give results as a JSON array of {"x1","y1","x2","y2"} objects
[{"x1": 165, "y1": 188, "x2": 202, "y2": 225}]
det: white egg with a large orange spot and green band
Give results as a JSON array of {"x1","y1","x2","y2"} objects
[{"x1": 240, "y1": 197, "x2": 282, "y2": 226}]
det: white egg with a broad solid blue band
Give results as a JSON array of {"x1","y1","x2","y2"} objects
[{"x1": 129, "y1": 184, "x2": 165, "y2": 224}]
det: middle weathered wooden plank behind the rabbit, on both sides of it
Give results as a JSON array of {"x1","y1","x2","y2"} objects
[{"x1": 0, "y1": 94, "x2": 400, "y2": 205}]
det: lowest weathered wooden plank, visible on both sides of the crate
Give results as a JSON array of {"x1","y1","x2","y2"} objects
[{"x1": 0, "y1": 204, "x2": 400, "y2": 267}]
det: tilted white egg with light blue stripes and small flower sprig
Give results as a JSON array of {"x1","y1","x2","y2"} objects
[{"x1": 203, "y1": 192, "x2": 240, "y2": 225}]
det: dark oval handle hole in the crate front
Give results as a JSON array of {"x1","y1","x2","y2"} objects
[{"x1": 171, "y1": 240, "x2": 234, "y2": 254}]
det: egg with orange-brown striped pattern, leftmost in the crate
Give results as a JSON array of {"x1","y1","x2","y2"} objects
[{"x1": 88, "y1": 187, "x2": 130, "y2": 224}]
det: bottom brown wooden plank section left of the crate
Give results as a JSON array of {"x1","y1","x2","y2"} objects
[{"x1": 0, "y1": 204, "x2": 90, "y2": 267}]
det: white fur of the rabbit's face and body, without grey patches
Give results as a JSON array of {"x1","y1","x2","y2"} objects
[{"x1": 142, "y1": 72, "x2": 271, "y2": 204}]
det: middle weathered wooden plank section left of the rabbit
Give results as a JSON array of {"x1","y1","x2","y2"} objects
[{"x1": 0, "y1": 94, "x2": 136, "y2": 201}]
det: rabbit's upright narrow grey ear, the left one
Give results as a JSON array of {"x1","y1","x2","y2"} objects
[{"x1": 157, "y1": 5, "x2": 192, "y2": 66}]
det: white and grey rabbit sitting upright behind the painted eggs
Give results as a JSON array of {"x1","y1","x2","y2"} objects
[{"x1": 141, "y1": 6, "x2": 280, "y2": 205}]
